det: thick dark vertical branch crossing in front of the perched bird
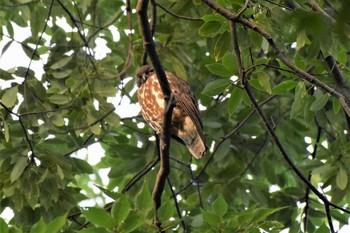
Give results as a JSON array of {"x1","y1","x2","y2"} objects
[{"x1": 136, "y1": 0, "x2": 174, "y2": 228}]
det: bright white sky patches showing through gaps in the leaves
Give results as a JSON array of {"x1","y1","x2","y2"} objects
[{"x1": 0, "y1": 20, "x2": 350, "y2": 233}]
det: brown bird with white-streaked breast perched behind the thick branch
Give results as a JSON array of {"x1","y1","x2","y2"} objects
[{"x1": 136, "y1": 65, "x2": 207, "y2": 159}]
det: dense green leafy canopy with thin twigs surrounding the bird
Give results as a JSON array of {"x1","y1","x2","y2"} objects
[{"x1": 0, "y1": 0, "x2": 350, "y2": 233}]
